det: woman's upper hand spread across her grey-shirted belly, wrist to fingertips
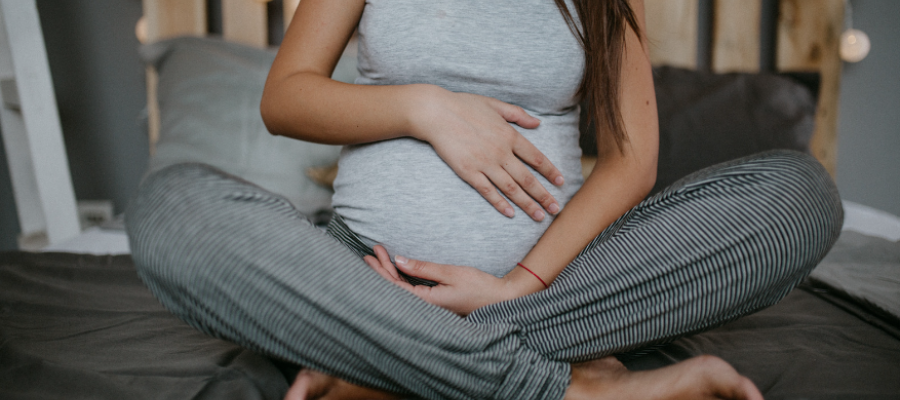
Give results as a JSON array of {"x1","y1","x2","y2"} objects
[{"x1": 410, "y1": 85, "x2": 564, "y2": 221}]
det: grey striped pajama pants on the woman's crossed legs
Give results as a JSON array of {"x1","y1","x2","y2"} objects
[{"x1": 126, "y1": 151, "x2": 843, "y2": 399}]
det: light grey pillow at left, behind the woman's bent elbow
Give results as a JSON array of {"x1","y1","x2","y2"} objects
[{"x1": 140, "y1": 37, "x2": 355, "y2": 214}]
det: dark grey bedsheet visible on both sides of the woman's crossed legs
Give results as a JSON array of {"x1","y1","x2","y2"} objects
[{"x1": 0, "y1": 230, "x2": 900, "y2": 399}]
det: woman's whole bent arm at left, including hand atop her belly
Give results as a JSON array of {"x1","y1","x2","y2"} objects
[{"x1": 260, "y1": 0, "x2": 563, "y2": 220}]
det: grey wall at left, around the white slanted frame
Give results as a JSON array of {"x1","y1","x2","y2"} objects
[{"x1": 0, "y1": 0, "x2": 148, "y2": 250}]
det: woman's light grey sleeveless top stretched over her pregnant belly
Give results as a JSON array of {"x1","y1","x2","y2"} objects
[{"x1": 333, "y1": 0, "x2": 584, "y2": 276}]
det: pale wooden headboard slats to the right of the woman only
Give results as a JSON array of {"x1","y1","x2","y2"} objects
[{"x1": 645, "y1": 0, "x2": 844, "y2": 176}]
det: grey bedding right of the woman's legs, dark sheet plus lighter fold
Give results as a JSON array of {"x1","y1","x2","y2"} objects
[{"x1": 626, "y1": 232, "x2": 900, "y2": 400}]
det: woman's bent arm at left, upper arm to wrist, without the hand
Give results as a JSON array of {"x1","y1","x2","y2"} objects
[{"x1": 260, "y1": 0, "x2": 432, "y2": 144}]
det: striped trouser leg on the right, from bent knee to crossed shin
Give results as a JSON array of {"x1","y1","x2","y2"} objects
[{"x1": 469, "y1": 150, "x2": 843, "y2": 362}]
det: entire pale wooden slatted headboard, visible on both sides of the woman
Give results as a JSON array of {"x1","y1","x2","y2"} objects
[{"x1": 142, "y1": 0, "x2": 845, "y2": 176}]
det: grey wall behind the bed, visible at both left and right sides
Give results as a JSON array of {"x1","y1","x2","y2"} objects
[{"x1": 0, "y1": 0, "x2": 900, "y2": 250}]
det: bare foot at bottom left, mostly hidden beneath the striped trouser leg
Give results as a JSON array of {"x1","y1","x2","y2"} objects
[{"x1": 284, "y1": 369, "x2": 400, "y2": 400}]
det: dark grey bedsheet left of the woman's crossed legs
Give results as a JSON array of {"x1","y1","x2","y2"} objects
[{"x1": 0, "y1": 252, "x2": 287, "y2": 400}]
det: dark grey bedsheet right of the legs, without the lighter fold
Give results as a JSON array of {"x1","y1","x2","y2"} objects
[{"x1": 626, "y1": 286, "x2": 900, "y2": 400}]
